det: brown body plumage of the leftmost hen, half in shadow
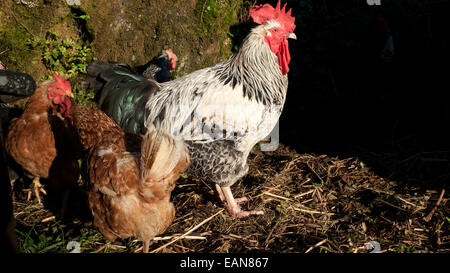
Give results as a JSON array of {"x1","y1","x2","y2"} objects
[{"x1": 6, "y1": 81, "x2": 80, "y2": 185}]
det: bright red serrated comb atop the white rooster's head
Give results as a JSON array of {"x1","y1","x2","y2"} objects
[{"x1": 250, "y1": 0, "x2": 295, "y2": 32}]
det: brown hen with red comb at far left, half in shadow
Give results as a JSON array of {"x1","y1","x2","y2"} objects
[{"x1": 6, "y1": 74, "x2": 81, "y2": 205}]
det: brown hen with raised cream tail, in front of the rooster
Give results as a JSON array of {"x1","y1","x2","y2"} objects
[{"x1": 72, "y1": 105, "x2": 189, "y2": 253}]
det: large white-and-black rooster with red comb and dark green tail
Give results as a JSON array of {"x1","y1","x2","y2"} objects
[{"x1": 88, "y1": 1, "x2": 296, "y2": 217}]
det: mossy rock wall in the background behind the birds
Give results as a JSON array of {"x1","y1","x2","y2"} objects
[{"x1": 0, "y1": 0, "x2": 246, "y2": 79}]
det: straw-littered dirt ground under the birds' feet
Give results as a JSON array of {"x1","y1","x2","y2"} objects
[{"x1": 13, "y1": 143, "x2": 450, "y2": 253}]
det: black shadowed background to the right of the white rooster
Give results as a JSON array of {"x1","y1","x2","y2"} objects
[{"x1": 253, "y1": 0, "x2": 450, "y2": 188}]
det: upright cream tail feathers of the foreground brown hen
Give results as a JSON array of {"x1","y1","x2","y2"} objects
[{"x1": 140, "y1": 125, "x2": 190, "y2": 181}]
